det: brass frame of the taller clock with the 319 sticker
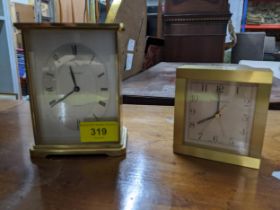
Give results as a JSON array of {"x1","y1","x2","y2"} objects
[{"x1": 15, "y1": 23, "x2": 128, "y2": 157}]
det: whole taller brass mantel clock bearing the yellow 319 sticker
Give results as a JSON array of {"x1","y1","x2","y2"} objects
[{"x1": 16, "y1": 24, "x2": 127, "y2": 156}]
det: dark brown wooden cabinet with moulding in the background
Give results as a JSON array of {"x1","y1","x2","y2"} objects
[{"x1": 163, "y1": 0, "x2": 231, "y2": 63}]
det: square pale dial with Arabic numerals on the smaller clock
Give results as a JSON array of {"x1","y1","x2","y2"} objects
[{"x1": 185, "y1": 80, "x2": 257, "y2": 155}]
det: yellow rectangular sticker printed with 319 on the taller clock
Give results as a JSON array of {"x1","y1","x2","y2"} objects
[{"x1": 80, "y1": 121, "x2": 119, "y2": 143}]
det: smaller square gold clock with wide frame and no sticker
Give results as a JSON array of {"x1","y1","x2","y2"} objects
[{"x1": 174, "y1": 64, "x2": 272, "y2": 168}]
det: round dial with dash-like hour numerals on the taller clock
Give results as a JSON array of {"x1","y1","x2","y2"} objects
[{"x1": 42, "y1": 43, "x2": 110, "y2": 130}]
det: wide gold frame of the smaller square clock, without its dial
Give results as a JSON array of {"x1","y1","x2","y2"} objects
[{"x1": 173, "y1": 64, "x2": 272, "y2": 169}]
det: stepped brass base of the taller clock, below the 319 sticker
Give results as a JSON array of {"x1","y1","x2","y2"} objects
[{"x1": 30, "y1": 127, "x2": 128, "y2": 157}]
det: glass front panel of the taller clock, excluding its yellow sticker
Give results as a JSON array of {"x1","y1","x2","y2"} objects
[{"x1": 26, "y1": 30, "x2": 119, "y2": 144}]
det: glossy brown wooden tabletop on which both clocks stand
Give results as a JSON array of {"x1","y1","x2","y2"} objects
[{"x1": 0, "y1": 103, "x2": 280, "y2": 210}]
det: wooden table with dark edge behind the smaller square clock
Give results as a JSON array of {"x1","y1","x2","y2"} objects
[{"x1": 122, "y1": 62, "x2": 280, "y2": 110}]
